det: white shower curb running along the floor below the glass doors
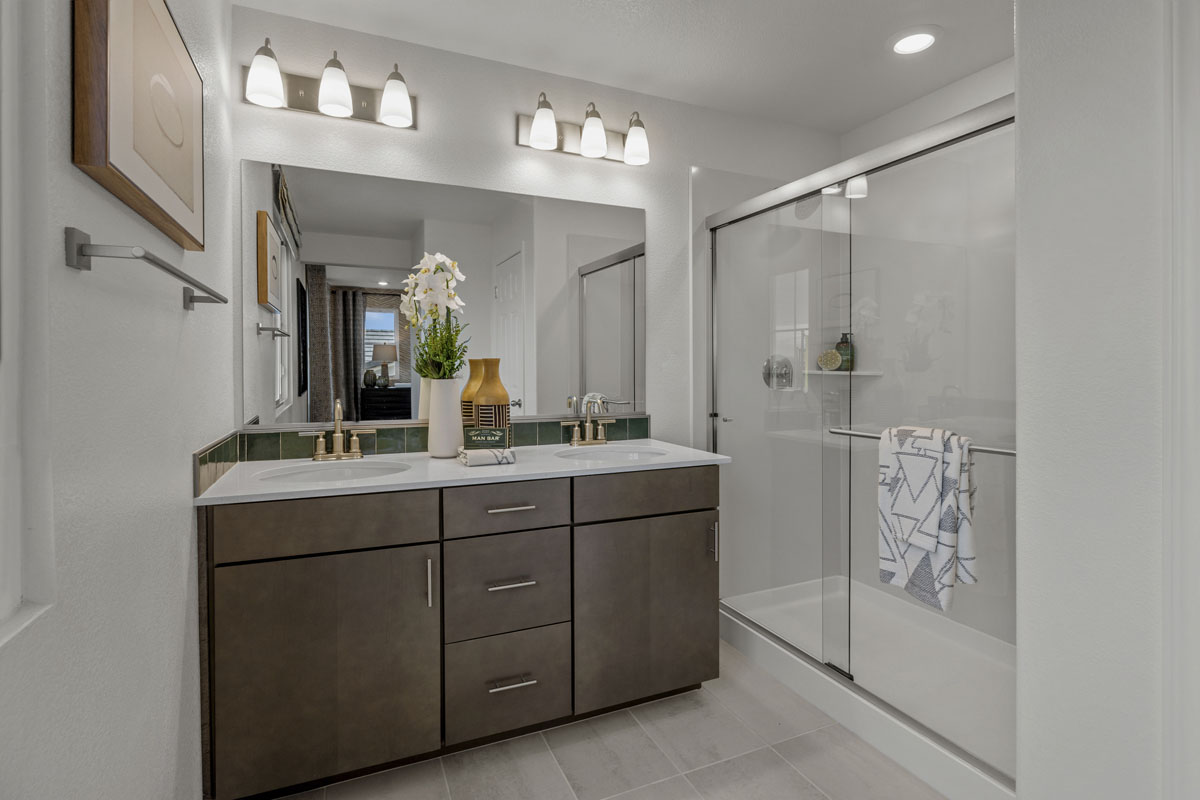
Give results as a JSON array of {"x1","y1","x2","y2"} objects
[{"x1": 721, "y1": 608, "x2": 1016, "y2": 800}]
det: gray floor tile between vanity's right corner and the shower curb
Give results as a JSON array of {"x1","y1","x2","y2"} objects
[{"x1": 704, "y1": 642, "x2": 833, "y2": 745}]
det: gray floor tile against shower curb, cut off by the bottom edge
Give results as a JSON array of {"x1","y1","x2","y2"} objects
[{"x1": 775, "y1": 724, "x2": 946, "y2": 800}]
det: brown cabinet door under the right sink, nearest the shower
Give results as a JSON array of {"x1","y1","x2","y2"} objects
[{"x1": 575, "y1": 511, "x2": 719, "y2": 714}]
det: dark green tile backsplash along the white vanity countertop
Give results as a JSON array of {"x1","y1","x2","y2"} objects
[{"x1": 192, "y1": 416, "x2": 650, "y2": 494}]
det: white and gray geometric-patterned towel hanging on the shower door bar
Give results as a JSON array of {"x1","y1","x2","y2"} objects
[{"x1": 880, "y1": 428, "x2": 976, "y2": 612}]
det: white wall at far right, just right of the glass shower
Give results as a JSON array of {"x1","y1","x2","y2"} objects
[{"x1": 1016, "y1": 0, "x2": 1166, "y2": 800}]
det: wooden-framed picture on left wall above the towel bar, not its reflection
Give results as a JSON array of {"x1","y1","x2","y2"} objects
[{"x1": 71, "y1": 0, "x2": 204, "y2": 251}]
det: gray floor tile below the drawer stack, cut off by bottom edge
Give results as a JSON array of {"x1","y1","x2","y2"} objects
[{"x1": 442, "y1": 733, "x2": 575, "y2": 800}]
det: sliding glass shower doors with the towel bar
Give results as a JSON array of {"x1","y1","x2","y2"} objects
[{"x1": 710, "y1": 109, "x2": 1015, "y2": 776}]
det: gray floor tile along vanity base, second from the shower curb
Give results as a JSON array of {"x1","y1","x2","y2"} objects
[{"x1": 631, "y1": 690, "x2": 764, "y2": 771}]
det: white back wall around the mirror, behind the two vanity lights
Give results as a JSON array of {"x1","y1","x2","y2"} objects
[{"x1": 233, "y1": 8, "x2": 839, "y2": 443}]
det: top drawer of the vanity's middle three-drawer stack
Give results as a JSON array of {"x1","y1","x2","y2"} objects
[{"x1": 443, "y1": 477, "x2": 571, "y2": 539}]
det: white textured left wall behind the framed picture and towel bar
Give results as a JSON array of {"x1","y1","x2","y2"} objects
[{"x1": 0, "y1": 0, "x2": 240, "y2": 800}]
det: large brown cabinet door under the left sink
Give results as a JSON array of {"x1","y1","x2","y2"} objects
[{"x1": 211, "y1": 545, "x2": 442, "y2": 800}]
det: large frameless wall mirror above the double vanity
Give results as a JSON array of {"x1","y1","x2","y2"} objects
[{"x1": 241, "y1": 161, "x2": 646, "y2": 426}]
